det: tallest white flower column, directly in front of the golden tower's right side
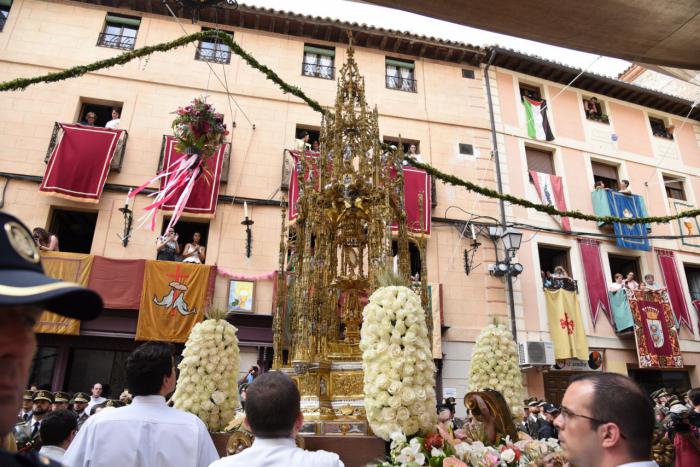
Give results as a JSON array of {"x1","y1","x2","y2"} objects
[{"x1": 360, "y1": 286, "x2": 437, "y2": 442}]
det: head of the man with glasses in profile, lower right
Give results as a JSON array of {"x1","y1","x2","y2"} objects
[{"x1": 554, "y1": 373, "x2": 656, "y2": 467}]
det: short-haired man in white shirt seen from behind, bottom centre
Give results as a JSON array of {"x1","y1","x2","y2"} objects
[{"x1": 210, "y1": 371, "x2": 344, "y2": 467}]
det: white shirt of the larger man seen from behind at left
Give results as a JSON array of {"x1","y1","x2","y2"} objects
[{"x1": 63, "y1": 395, "x2": 219, "y2": 467}]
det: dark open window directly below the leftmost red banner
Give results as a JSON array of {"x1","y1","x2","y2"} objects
[{"x1": 49, "y1": 209, "x2": 97, "y2": 253}]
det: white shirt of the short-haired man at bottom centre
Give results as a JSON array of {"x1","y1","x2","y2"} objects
[{"x1": 210, "y1": 438, "x2": 345, "y2": 467}]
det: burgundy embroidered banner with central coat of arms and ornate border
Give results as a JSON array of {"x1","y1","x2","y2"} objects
[{"x1": 627, "y1": 290, "x2": 683, "y2": 368}]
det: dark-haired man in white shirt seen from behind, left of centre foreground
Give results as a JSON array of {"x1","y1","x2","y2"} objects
[{"x1": 63, "y1": 342, "x2": 219, "y2": 467}]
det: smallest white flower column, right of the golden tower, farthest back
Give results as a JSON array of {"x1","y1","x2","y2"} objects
[{"x1": 469, "y1": 324, "x2": 524, "y2": 418}]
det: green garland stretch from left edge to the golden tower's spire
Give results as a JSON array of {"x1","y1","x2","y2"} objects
[{"x1": 0, "y1": 30, "x2": 326, "y2": 114}]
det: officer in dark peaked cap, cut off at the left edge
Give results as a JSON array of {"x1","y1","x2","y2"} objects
[{"x1": 0, "y1": 212, "x2": 102, "y2": 467}]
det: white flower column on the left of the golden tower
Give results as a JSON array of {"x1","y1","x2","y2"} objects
[{"x1": 173, "y1": 310, "x2": 240, "y2": 431}]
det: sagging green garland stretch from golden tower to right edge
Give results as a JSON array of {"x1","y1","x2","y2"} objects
[{"x1": 404, "y1": 156, "x2": 700, "y2": 224}]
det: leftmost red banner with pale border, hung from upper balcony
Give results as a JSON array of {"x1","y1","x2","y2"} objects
[{"x1": 39, "y1": 123, "x2": 124, "y2": 203}]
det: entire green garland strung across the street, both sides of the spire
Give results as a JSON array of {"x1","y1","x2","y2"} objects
[{"x1": 0, "y1": 30, "x2": 700, "y2": 228}]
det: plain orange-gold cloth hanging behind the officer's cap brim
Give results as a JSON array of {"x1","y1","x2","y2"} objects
[{"x1": 34, "y1": 251, "x2": 93, "y2": 336}]
